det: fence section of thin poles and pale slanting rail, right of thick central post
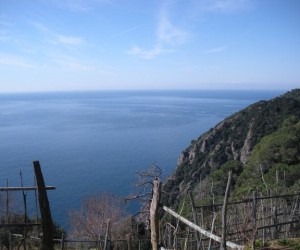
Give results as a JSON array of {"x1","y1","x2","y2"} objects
[{"x1": 158, "y1": 174, "x2": 300, "y2": 249}]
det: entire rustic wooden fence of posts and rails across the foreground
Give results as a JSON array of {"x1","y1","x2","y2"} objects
[{"x1": 0, "y1": 166, "x2": 300, "y2": 250}]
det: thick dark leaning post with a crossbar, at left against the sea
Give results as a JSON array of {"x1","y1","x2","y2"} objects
[{"x1": 33, "y1": 161, "x2": 54, "y2": 250}]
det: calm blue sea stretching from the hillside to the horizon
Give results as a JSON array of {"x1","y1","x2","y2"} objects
[{"x1": 0, "y1": 91, "x2": 284, "y2": 228}]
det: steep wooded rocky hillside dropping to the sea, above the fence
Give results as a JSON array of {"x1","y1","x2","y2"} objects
[{"x1": 164, "y1": 89, "x2": 300, "y2": 205}]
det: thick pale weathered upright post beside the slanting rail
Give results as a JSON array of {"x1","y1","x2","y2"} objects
[{"x1": 150, "y1": 178, "x2": 161, "y2": 250}]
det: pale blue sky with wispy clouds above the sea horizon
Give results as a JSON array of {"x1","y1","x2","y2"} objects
[{"x1": 0, "y1": 0, "x2": 300, "y2": 92}]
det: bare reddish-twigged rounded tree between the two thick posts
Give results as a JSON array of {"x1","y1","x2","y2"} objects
[{"x1": 70, "y1": 193, "x2": 125, "y2": 241}]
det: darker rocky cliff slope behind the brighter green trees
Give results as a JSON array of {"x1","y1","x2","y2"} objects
[{"x1": 164, "y1": 89, "x2": 300, "y2": 204}]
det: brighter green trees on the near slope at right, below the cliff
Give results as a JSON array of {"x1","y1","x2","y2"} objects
[{"x1": 236, "y1": 116, "x2": 300, "y2": 194}]
